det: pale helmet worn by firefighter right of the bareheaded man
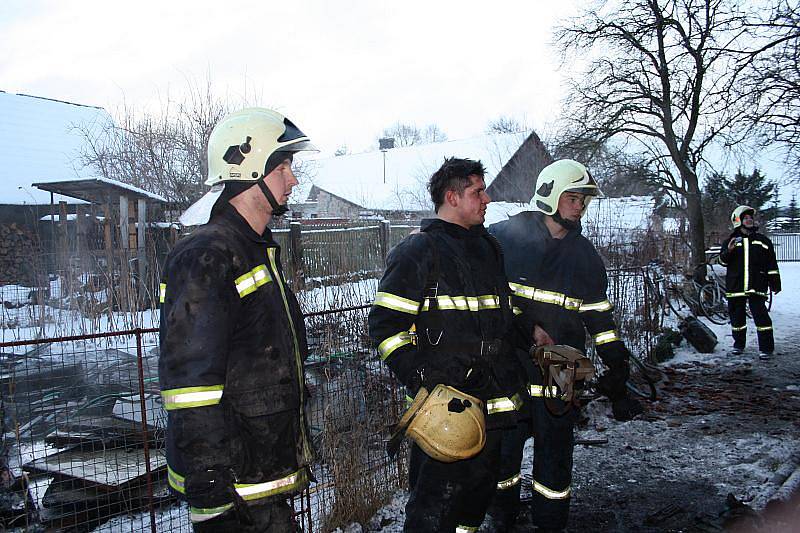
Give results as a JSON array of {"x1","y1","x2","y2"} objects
[{"x1": 532, "y1": 159, "x2": 603, "y2": 215}]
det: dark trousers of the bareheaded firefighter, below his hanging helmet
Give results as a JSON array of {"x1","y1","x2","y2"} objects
[{"x1": 403, "y1": 430, "x2": 501, "y2": 533}]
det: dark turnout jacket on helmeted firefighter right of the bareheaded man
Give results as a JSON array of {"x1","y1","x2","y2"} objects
[{"x1": 489, "y1": 211, "x2": 629, "y2": 400}]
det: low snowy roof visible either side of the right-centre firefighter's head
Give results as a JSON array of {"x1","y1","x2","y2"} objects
[{"x1": 484, "y1": 196, "x2": 656, "y2": 233}]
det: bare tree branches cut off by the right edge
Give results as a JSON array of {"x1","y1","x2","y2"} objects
[{"x1": 749, "y1": 0, "x2": 800, "y2": 172}]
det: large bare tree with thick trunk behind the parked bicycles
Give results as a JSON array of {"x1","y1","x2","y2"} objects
[{"x1": 556, "y1": 0, "x2": 759, "y2": 264}]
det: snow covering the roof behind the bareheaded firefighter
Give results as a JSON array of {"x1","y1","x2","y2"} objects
[{"x1": 295, "y1": 132, "x2": 528, "y2": 211}]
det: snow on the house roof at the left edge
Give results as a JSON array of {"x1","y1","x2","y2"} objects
[{"x1": 0, "y1": 92, "x2": 111, "y2": 204}]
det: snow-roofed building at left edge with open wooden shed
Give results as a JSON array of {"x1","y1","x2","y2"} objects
[{"x1": 0, "y1": 91, "x2": 165, "y2": 282}]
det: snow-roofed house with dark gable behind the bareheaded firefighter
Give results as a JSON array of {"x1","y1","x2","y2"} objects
[{"x1": 291, "y1": 132, "x2": 549, "y2": 219}]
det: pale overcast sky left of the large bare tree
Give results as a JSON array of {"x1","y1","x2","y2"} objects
[{"x1": 0, "y1": 0, "x2": 573, "y2": 151}]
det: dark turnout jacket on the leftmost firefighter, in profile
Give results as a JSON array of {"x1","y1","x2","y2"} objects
[{"x1": 159, "y1": 209, "x2": 311, "y2": 519}]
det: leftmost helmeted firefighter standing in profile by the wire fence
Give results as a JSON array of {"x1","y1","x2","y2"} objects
[{"x1": 159, "y1": 108, "x2": 314, "y2": 532}]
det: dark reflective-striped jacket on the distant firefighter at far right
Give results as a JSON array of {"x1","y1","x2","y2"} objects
[{"x1": 719, "y1": 228, "x2": 781, "y2": 298}]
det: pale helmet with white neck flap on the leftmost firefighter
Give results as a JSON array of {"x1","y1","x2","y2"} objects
[{"x1": 180, "y1": 107, "x2": 317, "y2": 226}]
